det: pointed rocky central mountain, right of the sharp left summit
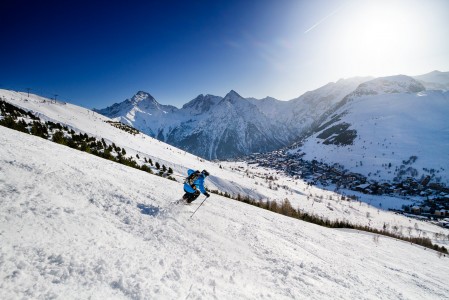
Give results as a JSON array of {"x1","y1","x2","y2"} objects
[{"x1": 166, "y1": 91, "x2": 290, "y2": 159}]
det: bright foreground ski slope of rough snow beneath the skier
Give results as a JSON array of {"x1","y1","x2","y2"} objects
[{"x1": 0, "y1": 127, "x2": 449, "y2": 299}]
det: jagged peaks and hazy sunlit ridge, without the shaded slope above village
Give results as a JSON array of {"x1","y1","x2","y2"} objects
[{"x1": 95, "y1": 71, "x2": 449, "y2": 159}]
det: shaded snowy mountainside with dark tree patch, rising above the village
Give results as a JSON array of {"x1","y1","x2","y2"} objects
[{"x1": 290, "y1": 76, "x2": 449, "y2": 185}]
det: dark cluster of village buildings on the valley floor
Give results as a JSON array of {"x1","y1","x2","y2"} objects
[{"x1": 245, "y1": 150, "x2": 449, "y2": 228}]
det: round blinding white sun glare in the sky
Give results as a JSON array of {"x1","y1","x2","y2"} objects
[{"x1": 326, "y1": 1, "x2": 423, "y2": 76}]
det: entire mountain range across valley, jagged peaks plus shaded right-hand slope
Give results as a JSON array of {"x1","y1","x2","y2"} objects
[{"x1": 18, "y1": 71, "x2": 449, "y2": 182}]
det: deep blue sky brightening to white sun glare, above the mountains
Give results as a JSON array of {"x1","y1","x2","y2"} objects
[{"x1": 0, "y1": 0, "x2": 449, "y2": 108}]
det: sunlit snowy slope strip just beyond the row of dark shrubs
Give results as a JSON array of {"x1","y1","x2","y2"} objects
[{"x1": 0, "y1": 90, "x2": 449, "y2": 246}]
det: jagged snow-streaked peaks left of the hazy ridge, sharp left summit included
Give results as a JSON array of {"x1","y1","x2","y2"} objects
[{"x1": 95, "y1": 91, "x2": 294, "y2": 159}]
